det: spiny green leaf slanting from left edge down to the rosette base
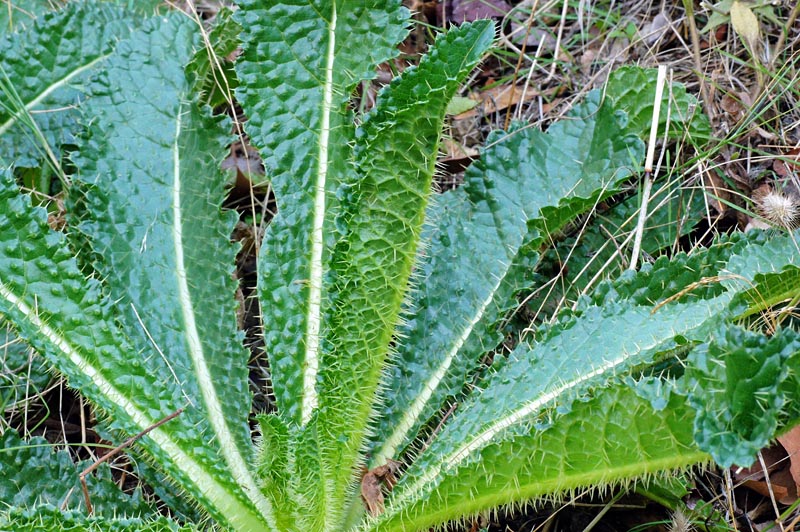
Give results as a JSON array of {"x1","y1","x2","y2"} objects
[{"x1": 0, "y1": 165, "x2": 253, "y2": 517}]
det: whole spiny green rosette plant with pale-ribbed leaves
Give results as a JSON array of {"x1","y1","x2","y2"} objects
[{"x1": 0, "y1": 0, "x2": 800, "y2": 532}]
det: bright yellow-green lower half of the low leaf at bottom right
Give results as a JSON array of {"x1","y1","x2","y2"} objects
[{"x1": 364, "y1": 385, "x2": 708, "y2": 532}]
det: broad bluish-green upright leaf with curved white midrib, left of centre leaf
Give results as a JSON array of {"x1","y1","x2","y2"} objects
[{"x1": 72, "y1": 16, "x2": 280, "y2": 528}]
